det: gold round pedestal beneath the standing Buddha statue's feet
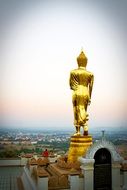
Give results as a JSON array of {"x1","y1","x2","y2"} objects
[{"x1": 68, "y1": 135, "x2": 92, "y2": 162}]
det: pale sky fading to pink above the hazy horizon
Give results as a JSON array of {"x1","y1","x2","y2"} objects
[{"x1": 0, "y1": 0, "x2": 127, "y2": 129}]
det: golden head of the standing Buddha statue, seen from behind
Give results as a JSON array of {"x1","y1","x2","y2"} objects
[{"x1": 77, "y1": 51, "x2": 87, "y2": 67}]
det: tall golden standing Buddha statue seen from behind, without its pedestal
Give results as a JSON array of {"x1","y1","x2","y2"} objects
[{"x1": 70, "y1": 51, "x2": 94, "y2": 135}]
